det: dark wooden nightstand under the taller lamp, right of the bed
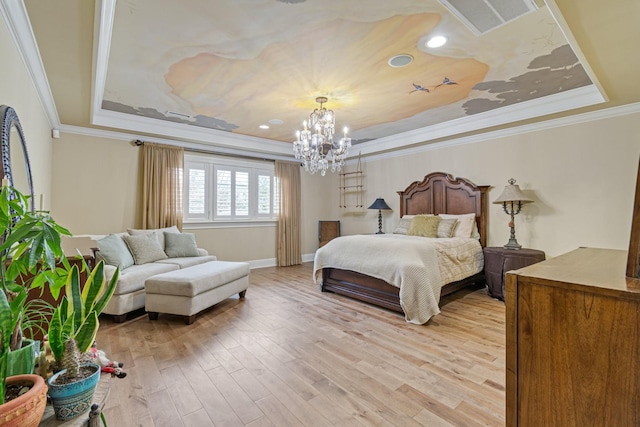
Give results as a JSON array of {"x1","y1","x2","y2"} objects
[{"x1": 484, "y1": 247, "x2": 545, "y2": 301}]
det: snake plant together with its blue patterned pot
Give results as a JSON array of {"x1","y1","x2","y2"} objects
[{"x1": 47, "y1": 261, "x2": 119, "y2": 420}]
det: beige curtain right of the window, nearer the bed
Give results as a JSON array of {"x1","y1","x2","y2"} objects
[{"x1": 275, "y1": 161, "x2": 302, "y2": 267}]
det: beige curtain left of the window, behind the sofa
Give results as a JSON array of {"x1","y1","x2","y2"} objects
[{"x1": 142, "y1": 142, "x2": 184, "y2": 229}]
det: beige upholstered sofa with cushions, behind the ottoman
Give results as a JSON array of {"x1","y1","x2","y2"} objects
[{"x1": 92, "y1": 227, "x2": 216, "y2": 322}]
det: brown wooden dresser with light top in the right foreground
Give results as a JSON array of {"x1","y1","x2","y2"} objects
[{"x1": 506, "y1": 248, "x2": 640, "y2": 427}]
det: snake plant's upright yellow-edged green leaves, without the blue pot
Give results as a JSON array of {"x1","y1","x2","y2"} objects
[{"x1": 48, "y1": 261, "x2": 120, "y2": 377}]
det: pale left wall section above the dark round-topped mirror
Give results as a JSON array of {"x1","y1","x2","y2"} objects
[{"x1": 0, "y1": 12, "x2": 52, "y2": 209}]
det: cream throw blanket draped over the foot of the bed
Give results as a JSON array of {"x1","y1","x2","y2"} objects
[{"x1": 313, "y1": 234, "x2": 443, "y2": 324}]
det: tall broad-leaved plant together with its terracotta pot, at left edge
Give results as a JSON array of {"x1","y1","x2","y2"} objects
[{"x1": 0, "y1": 183, "x2": 70, "y2": 426}]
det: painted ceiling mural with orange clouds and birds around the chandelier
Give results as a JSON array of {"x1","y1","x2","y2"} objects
[{"x1": 102, "y1": 0, "x2": 592, "y2": 143}]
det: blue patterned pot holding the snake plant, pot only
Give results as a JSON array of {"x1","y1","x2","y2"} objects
[{"x1": 47, "y1": 363, "x2": 100, "y2": 420}]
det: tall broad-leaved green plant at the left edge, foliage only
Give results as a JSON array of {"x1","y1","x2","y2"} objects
[{"x1": 0, "y1": 186, "x2": 71, "y2": 403}]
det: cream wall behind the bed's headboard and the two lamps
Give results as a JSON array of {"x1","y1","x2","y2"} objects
[{"x1": 334, "y1": 108, "x2": 640, "y2": 256}]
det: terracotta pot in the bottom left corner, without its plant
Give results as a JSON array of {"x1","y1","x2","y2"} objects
[{"x1": 0, "y1": 375, "x2": 47, "y2": 427}]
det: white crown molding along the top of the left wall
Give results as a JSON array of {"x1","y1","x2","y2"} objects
[{"x1": 0, "y1": 0, "x2": 60, "y2": 129}]
